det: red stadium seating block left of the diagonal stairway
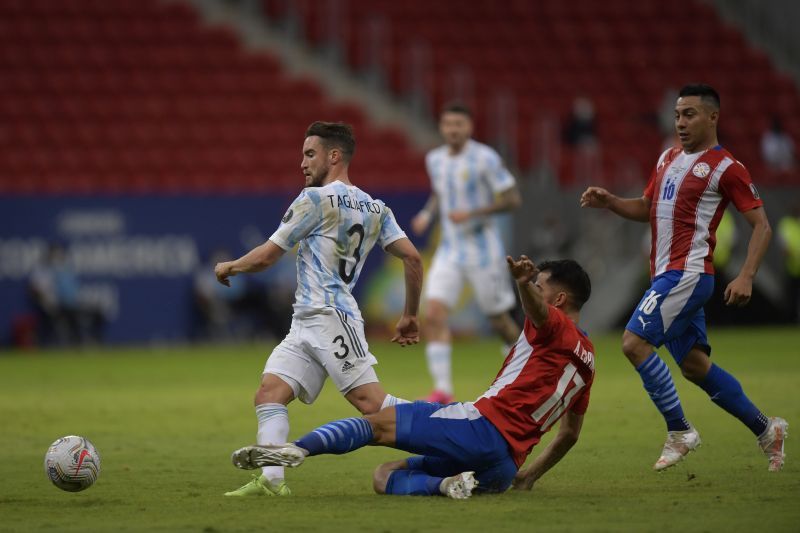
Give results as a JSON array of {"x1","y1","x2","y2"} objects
[{"x1": 0, "y1": 0, "x2": 427, "y2": 194}]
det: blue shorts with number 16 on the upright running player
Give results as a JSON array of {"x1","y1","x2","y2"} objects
[{"x1": 625, "y1": 270, "x2": 714, "y2": 365}]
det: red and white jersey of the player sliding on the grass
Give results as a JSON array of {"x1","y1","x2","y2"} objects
[{"x1": 475, "y1": 306, "x2": 594, "y2": 466}]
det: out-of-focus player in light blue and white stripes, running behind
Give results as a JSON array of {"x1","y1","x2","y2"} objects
[{"x1": 411, "y1": 104, "x2": 521, "y2": 403}]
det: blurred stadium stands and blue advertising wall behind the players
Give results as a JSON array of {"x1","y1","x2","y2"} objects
[{"x1": 0, "y1": 0, "x2": 800, "y2": 348}]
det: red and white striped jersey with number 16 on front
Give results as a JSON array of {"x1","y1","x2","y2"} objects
[{"x1": 644, "y1": 146, "x2": 764, "y2": 277}]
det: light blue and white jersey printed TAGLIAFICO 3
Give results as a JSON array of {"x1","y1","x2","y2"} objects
[{"x1": 269, "y1": 181, "x2": 406, "y2": 320}]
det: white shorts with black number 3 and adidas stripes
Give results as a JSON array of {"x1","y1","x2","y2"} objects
[{"x1": 264, "y1": 307, "x2": 378, "y2": 403}]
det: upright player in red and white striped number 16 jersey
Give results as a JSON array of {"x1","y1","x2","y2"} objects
[{"x1": 581, "y1": 84, "x2": 788, "y2": 472}]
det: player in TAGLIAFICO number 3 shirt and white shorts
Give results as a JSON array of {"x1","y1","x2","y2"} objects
[{"x1": 214, "y1": 122, "x2": 422, "y2": 496}]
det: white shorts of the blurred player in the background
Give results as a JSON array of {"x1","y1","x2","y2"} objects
[{"x1": 425, "y1": 254, "x2": 516, "y2": 316}]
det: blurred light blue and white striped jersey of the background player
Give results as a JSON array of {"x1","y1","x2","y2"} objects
[{"x1": 425, "y1": 140, "x2": 516, "y2": 266}]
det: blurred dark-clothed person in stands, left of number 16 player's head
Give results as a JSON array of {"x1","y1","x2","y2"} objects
[{"x1": 563, "y1": 96, "x2": 600, "y2": 183}]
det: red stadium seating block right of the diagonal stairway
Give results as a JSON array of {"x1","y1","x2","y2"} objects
[{"x1": 276, "y1": 0, "x2": 800, "y2": 184}]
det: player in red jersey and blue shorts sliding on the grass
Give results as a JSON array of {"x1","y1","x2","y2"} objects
[{"x1": 232, "y1": 256, "x2": 594, "y2": 499}]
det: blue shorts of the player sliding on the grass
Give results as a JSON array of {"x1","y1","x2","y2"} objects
[{"x1": 395, "y1": 402, "x2": 518, "y2": 492}]
